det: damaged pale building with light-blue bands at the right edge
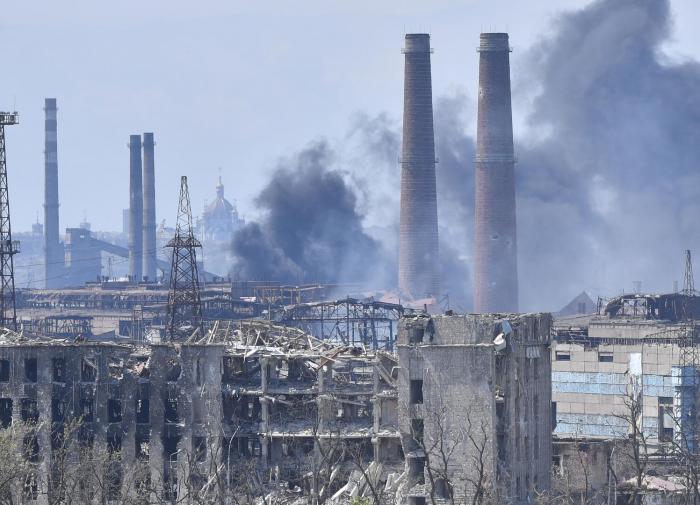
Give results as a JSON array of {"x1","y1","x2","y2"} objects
[{"x1": 552, "y1": 293, "x2": 700, "y2": 487}]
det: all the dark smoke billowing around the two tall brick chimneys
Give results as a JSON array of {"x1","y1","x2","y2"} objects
[{"x1": 234, "y1": 0, "x2": 700, "y2": 311}]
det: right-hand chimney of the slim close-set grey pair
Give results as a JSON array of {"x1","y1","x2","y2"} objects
[{"x1": 143, "y1": 133, "x2": 157, "y2": 281}]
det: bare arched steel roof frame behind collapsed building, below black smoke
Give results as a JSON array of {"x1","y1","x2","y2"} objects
[{"x1": 274, "y1": 298, "x2": 407, "y2": 351}]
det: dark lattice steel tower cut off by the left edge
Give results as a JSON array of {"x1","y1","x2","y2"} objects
[{"x1": 0, "y1": 112, "x2": 19, "y2": 330}]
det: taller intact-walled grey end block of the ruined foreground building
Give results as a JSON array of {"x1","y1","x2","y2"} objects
[{"x1": 397, "y1": 314, "x2": 551, "y2": 505}]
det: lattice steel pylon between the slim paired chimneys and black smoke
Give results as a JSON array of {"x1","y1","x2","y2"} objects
[{"x1": 167, "y1": 176, "x2": 203, "y2": 340}]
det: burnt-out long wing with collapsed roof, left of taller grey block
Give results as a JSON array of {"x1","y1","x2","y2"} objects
[{"x1": 0, "y1": 321, "x2": 403, "y2": 503}]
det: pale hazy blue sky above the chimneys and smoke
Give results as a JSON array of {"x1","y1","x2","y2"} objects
[{"x1": 0, "y1": 0, "x2": 700, "y2": 231}]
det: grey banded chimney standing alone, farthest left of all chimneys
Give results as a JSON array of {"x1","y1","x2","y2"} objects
[{"x1": 44, "y1": 98, "x2": 64, "y2": 288}]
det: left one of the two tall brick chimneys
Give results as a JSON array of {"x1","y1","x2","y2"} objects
[{"x1": 399, "y1": 33, "x2": 439, "y2": 298}]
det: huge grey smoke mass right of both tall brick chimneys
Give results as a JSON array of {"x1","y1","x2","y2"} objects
[{"x1": 514, "y1": 0, "x2": 700, "y2": 309}]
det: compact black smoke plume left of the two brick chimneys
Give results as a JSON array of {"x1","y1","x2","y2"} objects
[{"x1": 233, "y1": 141, "x2": 383, "y2": 283}]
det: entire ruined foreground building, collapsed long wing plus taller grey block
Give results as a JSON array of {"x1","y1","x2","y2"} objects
[{"x1": 0, "y1": 315, "x2": 551, "y2": 504}]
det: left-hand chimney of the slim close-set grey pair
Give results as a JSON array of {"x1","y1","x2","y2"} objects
[{"x1": 129, "y1": 135, "x2": 143, "y2": 282}]
